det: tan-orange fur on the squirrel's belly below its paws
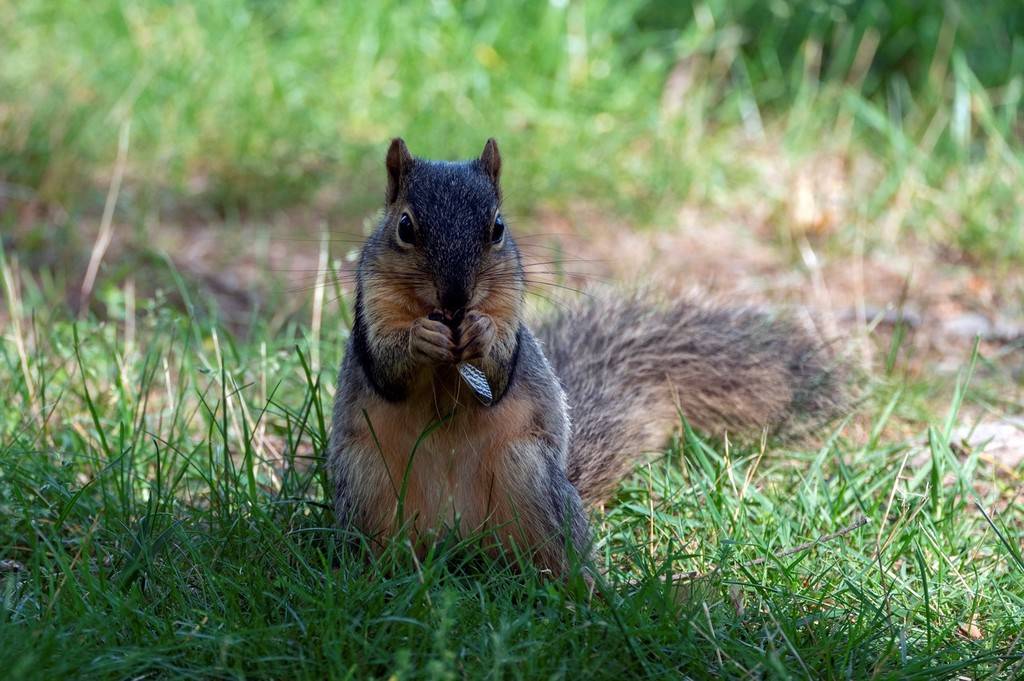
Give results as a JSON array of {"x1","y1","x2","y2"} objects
[{"x1": 359, "y1": 386, "x2": 537, "y2": 534}]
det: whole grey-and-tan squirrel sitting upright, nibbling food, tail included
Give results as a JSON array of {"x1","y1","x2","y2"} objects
[{"x1": 329, "y1": 138, "x2": 844, "y2": 573}]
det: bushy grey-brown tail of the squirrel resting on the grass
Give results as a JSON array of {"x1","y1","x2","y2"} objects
[{"x1": 538, "y1": 295, "x2": 847, "y2": 504}]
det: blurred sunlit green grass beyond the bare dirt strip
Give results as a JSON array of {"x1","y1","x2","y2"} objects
[{"x1": 0, "y1": 0, "x2": 1024, "y2": 258}]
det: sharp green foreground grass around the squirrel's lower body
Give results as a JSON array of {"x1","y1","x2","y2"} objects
[{"x1": 0, "y1": 248, "x2": 1024, "y2": 679}]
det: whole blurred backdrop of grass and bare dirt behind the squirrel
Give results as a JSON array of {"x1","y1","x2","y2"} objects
[{"x1": 0, "y1": 0, "x2": 1024, "y2": 393}]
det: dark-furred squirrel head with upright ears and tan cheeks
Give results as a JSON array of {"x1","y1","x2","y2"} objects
[{"x1": 360, "y1": 138, "x2": 523, "y2": 324}]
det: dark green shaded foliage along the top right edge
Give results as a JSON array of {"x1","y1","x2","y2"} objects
[{"x1": 636, "y1": 0, "x2": 1024, "y2": 95}]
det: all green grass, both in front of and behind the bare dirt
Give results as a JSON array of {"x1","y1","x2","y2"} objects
[{"x1": 0, "y1": 0, "x2": 1024, "y2": 679}]
